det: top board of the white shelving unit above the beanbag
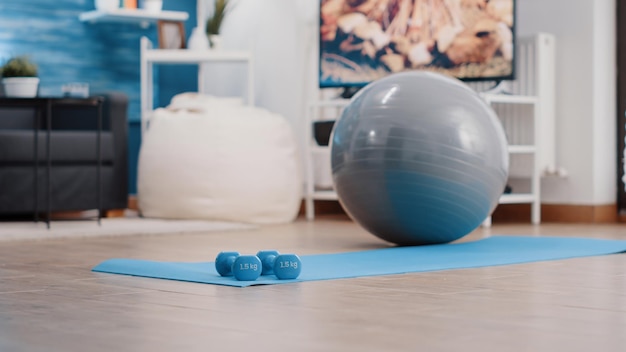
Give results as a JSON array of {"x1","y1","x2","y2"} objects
[{"x1": 144, "y1": 49, "x2": 252, "y2": 64}]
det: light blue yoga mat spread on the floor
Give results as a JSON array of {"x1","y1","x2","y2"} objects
[{"x1": 93, "y1": 236, "x2": 626, "y2": 287}]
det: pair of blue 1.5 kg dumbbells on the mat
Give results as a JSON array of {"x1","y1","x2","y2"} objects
[{"x1": 215, "y1": 250, "x2": 302, "y2": 281}]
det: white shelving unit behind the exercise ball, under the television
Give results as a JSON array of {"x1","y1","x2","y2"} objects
[{"x1": 305, "y1": 94, "x2": 541, "y2": 226}]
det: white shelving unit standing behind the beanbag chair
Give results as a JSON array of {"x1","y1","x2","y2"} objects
[{"x1": 141, "y1": 37, "x2": 254, "y2": 133}]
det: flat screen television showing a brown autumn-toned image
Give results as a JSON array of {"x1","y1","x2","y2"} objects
[{"x1": 319, "y1": 0, "x2": 515, "y2": 88}]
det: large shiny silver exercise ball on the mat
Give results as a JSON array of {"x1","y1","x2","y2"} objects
[{"x1": 331, "y1": 71, "x2": 509, "y2": 245}]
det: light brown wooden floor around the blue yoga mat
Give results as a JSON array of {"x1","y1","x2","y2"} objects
[{"x1": 0, "y1": 217, "x2": 626, "y2": 352}]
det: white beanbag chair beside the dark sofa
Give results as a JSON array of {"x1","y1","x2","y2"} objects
[{"x1": 137, "y1": 93, "x2": 302, "y2": 224}]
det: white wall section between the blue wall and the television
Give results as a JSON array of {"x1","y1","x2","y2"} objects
[{"x1": 196, "y1": 0, "x2": 318, "y2": 150}]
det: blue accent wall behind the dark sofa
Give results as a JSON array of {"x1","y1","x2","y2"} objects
[{"x1": 0, "y1": 0, "x2": 197, "y2": 194}]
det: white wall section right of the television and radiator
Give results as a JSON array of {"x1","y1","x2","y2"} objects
[{"x1": 517, "y1": 0, "x2": 617, "y2": 205}]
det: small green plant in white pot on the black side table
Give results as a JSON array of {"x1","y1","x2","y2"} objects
[{"x1": 0, "y1": 56, "x2": 39, "y2": 98}]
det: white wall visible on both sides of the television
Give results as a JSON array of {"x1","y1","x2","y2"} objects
[{"x1": 204, "y1": 0, "x2": 617, "y2": 205}]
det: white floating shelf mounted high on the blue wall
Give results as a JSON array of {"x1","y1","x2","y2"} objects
[{"x1": 78, "y1": 8, "x2": 189, "y2": 27}]
